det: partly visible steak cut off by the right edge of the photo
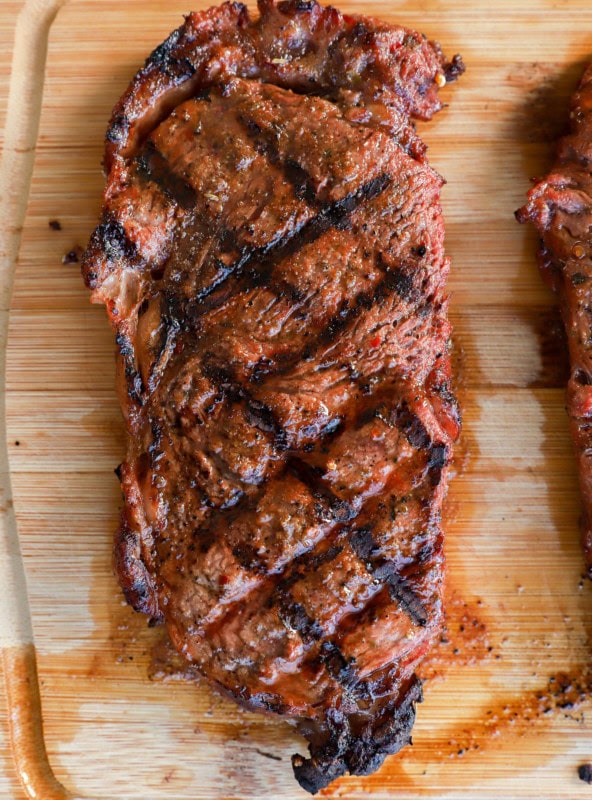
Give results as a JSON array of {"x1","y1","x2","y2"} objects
[{"x1": 516, "y1": 65, "x2": 592, "y2": 577}]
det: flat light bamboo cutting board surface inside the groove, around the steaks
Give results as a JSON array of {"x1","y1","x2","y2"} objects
[{"x1": 5, "y1": 0, "x2": 592, "y2": 800}]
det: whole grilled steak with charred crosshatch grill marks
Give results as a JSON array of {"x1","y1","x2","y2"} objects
[{"x1": 83, "y1": 0, "x2": 464, "y2": 792}]
